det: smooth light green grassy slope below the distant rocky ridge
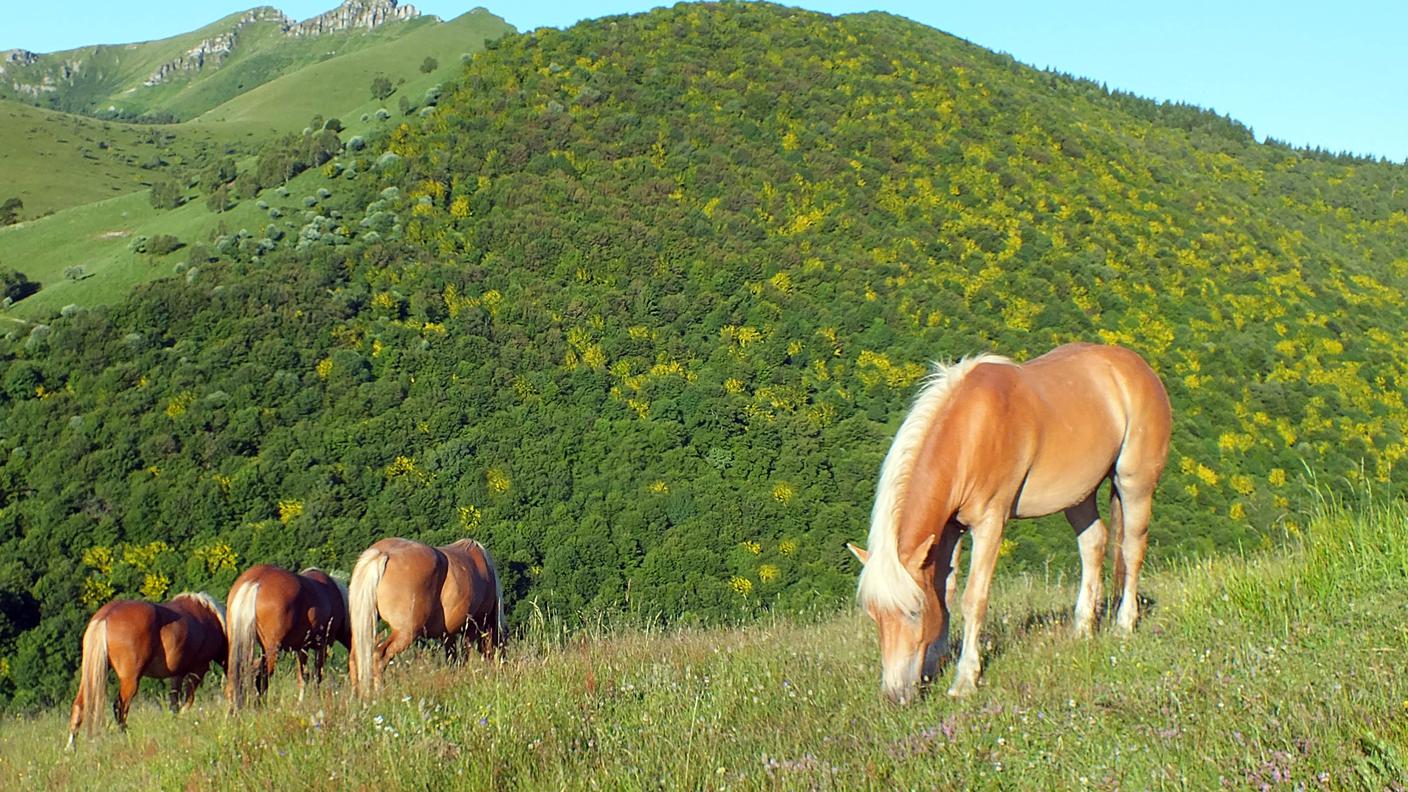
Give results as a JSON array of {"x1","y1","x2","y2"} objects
[{"x1": 0, "y1": 8, "x2": 511, "y2": 318}]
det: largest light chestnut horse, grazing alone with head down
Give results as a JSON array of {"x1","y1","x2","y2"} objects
[{"x1": 850, "y1": 344, "x2": 1173, "y2": 703}]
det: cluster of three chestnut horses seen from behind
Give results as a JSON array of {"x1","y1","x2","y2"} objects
[{"x1": 69, "y1": 529, "x2": 504, "y2": 748}]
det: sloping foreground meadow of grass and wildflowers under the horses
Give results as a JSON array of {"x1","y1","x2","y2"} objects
[{"x1": 0, "y1": 507, "x2": 1408, "y2": 789}]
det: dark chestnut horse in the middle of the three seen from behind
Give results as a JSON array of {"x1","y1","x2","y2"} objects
[{"x1": 225, "y1": 564, "x2": 352, "y2": 709}]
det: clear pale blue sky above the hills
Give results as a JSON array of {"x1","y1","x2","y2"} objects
[{"x1": 11, "y1": 0, "x2": 1408, "y2": 162}]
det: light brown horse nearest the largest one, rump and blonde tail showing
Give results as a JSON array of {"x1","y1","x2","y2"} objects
[{"x1": 348, "y1": 538, "x2": 504, "y2": 696}]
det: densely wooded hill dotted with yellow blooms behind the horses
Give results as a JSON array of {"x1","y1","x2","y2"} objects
[{"x1": 0, "y1": 3, "x2": 1408, "y2": 709}]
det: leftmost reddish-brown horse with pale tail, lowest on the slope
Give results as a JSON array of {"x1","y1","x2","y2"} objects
[{"x1": 69, "y1": 592, "x2": 225, "y2": 748}]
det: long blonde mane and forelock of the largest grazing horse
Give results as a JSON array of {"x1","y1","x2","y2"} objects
[{"x1": 856, "y1": 355, "x2": 1012, "y2": 613}]
